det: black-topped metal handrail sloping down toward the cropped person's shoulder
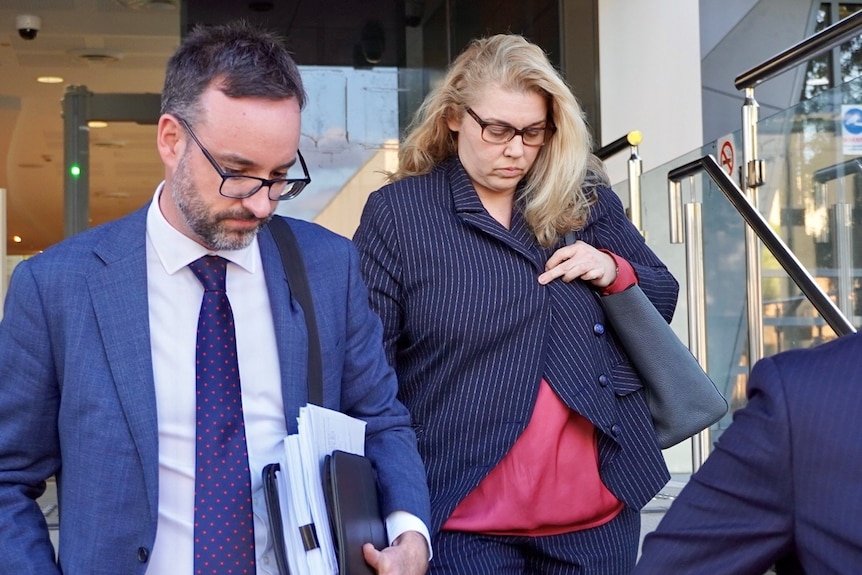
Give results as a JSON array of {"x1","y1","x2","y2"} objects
[{"x1": 667, "y1": 155, "x2": 856, "y2": 336}]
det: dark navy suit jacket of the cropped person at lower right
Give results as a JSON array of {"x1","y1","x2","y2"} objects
[{"x1": 635, "y1": 335, "x2": 862, "y2": 575}]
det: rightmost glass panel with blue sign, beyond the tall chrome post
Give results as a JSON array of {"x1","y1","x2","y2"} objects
[{"x1": 758, "y1": 80, "x2": 862, "y2": 355}]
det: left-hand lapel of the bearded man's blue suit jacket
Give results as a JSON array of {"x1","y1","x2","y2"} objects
[{"x1": 88, "y1": 206, "x2": 158, "y2": 519}]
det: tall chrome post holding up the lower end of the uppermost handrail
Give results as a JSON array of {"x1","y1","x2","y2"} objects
[{"x1": 742, "y1": 87, "x2": 763, "y2": 369}]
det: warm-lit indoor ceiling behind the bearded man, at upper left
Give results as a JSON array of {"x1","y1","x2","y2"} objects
[{"x1": 0, "y1": 0, "x2": 180, "y2": 254}]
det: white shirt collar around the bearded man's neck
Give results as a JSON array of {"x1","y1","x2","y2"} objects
[{"x1": 147, "y1": 182, "x2": 258, "y2": 275}]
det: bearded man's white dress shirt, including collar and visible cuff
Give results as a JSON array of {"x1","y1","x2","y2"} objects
[{"x1": 147, "y1": 184, "x2": 438, "y2": 575}]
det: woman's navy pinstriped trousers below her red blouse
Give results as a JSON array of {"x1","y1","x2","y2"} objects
[{"x1": 429, "y1": 507, "x2": 640, "y2": 575}]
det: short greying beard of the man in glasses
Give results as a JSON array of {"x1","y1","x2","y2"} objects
[{"x1": 171, "y1": 156, "x2": 272, "y2": 250}]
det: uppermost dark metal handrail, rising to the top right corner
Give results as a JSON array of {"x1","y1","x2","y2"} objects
[{"x1": 734, "y1": 11, "x2": 862, "y2": 90}]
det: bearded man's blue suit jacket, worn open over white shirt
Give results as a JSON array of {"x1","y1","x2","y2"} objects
[{"x1": 0, "y1": 208, "x2": 429, "y2": 575}]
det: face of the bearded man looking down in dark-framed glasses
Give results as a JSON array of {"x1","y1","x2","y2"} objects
[{"x1": 159, "y1": 88, "x2": 300, "y2": 250}]
